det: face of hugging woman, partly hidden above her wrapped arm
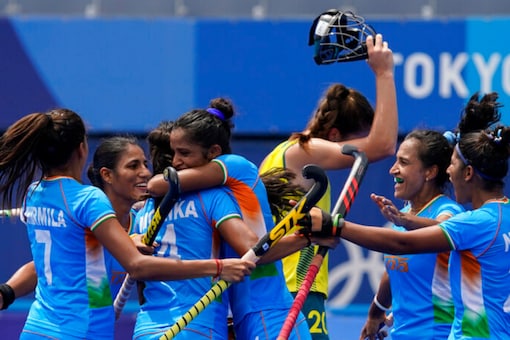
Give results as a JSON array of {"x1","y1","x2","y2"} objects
[{"x1": 170, "y1": 128, "x2": 214, "y2": 170}]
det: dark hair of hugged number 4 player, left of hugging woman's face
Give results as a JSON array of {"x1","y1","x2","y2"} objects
[{"x1": 147, "y1": 120, "x2": 174, "y2": 174}]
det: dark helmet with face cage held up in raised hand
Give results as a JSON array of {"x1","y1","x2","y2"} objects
[{"x1": 308, "y1": 9, "x2": 376, "y2": 65}]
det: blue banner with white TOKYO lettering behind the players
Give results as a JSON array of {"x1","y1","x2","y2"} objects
[{"x1": 0, "y1": 18, "x2": 510, "y2": 135}]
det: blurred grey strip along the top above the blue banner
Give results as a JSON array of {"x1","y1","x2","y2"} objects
[{"x1": 0, "y1": 0, "x2": 510, "y2": 19}]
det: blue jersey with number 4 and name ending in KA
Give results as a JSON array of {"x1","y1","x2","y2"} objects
[{"x1": 134, "y1": 187, "x2": 240, "y2": 339}]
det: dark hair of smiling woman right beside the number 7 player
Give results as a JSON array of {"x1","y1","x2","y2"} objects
[{"x1": 87, "y1": 136, "x2": 140, "y2": 189}]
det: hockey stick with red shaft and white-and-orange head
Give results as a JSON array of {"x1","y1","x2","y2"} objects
[{"x1": 277, "y1": 144, "x2": 368, "y2": 340}]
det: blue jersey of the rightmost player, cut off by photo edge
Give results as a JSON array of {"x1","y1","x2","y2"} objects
[{"x1": 440, "y1": 198, "x2": 510, "y2": 339}]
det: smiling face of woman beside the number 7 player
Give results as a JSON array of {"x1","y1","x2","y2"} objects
[{"x1": 101, "y1": 144, "x2": 151, "y2": 204}]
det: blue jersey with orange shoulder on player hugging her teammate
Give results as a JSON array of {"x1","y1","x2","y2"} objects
[{"x1": 213, "y1": 154, "x2": 309, "y2": 339}]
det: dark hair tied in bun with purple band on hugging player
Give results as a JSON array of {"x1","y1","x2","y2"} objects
[{"x1": 173, "y1": 98, "x2": 234, "y2": 154}]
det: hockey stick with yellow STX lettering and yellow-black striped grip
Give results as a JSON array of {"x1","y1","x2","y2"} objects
[{"x1": 159, "y1": 165, "x2": 328, "y2": 340}]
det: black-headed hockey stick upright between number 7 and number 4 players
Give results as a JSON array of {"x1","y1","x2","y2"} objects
[{"x1": 113, "y1": 166, "x2": 180, "y2": 319}]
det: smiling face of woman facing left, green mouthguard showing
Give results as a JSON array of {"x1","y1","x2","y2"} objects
[{"x1": 389, "y1": 138, "x2": 429, "y2": 201}]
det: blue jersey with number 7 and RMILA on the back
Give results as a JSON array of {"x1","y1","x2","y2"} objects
[{"x1": 21, "y1": 177, "x2": 115, "y2": 339}]
